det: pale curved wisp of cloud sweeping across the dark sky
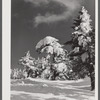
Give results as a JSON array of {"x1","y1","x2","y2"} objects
[{"x1": 25, "y1": 0, "x2": 82, "y2": 26}]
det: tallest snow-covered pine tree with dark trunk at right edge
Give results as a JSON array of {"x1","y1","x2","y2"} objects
[{"x1": 65, "y1": 7, "x2": 95, "y2": 90}]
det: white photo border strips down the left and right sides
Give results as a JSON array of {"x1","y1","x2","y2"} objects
[{"x1": 2, "y1": 0, "x2": 98, "y2": 100}]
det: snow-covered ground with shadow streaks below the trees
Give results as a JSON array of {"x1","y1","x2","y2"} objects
[{"x1": 11, "y1": 78, "x2": 95, "y2": 100}]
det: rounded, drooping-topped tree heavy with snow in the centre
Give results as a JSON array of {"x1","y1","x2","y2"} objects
[{"x1": 36, "y1": 36, "x2": 72, "y2": 79}]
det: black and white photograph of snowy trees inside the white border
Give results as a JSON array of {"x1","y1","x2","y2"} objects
[{"x1": 6, "y1": 0, "x2": 98, "y2": 100}]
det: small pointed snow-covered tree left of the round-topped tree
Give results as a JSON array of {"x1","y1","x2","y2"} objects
[{"x1": 19, "y1": 51, "x2": 38, "y2": 77}]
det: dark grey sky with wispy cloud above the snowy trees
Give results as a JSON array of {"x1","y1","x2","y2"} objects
[{"x1": 11, "y1": 0, "x2": 95, "y2": 68}]
